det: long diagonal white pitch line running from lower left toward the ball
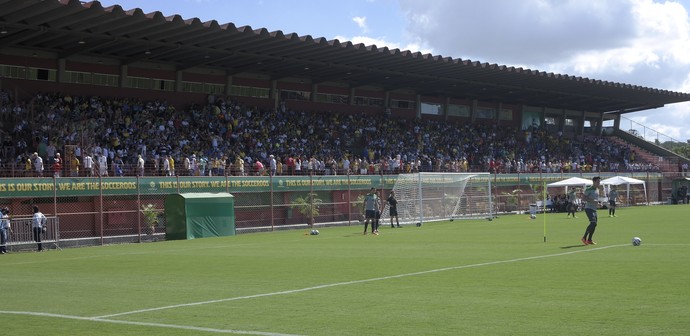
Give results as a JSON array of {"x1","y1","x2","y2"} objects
[{"x1": 93, "y1": 244, "x2": 628, "y2": 319}]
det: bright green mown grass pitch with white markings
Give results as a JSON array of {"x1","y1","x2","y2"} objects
[{"x1": 0, "y1": 205, "x2": 690, "y2": 336}]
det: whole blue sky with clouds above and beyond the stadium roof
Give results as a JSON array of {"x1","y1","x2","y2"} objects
[{"x1": 101, "y1": 0, "x2": 690, "y2": 141}]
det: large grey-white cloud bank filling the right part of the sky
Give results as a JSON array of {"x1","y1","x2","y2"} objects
[{"x1": 392, "y1": 0, "x2": 690, "y2": 141}]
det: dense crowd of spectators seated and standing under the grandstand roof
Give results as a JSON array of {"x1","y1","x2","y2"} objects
[{"x1": 0, "y1": 92, "x2": 656, "y2": 176}]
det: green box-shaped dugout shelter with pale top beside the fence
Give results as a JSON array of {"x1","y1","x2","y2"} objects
[{"x1": 165, "y1": 193, "x2": 235, "y2": 240}]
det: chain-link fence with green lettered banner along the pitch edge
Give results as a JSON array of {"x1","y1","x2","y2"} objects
[{"x1": 0, "y1": 173, "x2": 690, "y2": 249}]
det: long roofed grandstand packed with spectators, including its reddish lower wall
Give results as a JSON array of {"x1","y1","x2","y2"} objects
[{"x1": 0, "y1": 0, "x2": 690, "y2": 247}]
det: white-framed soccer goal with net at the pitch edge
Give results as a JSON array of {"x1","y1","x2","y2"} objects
[{"x1": 381, "y1": 173, "x2": 494, "y2": 225}]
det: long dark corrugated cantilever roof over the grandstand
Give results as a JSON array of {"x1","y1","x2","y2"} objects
[{"x1": 0, "y1": 0, "x2": 690, "y2": 113}]
